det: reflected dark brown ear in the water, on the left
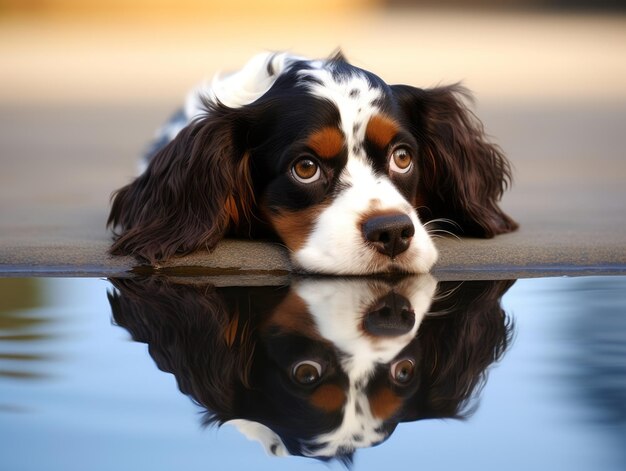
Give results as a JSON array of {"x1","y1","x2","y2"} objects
[{"x1": 108, "y1": 277, "x2": 255, "y2": 420}]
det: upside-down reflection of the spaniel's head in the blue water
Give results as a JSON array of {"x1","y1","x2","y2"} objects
[{"x1": 109, "y1": 275, "x2": 512, "y2": 461}]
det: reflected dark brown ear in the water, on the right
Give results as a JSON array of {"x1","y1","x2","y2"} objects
[{"x1": 403, "y1": 280, "x2": 514, "y2": 421}]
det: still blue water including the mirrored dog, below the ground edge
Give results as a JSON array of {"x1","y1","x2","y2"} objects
[{"x1": 0, "y1": 277, "x2": 626, "y2": 471}]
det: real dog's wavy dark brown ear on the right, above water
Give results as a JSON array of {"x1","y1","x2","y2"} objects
[{"x1": 392, "y1": 85, "x2": 517, "y2": 237}]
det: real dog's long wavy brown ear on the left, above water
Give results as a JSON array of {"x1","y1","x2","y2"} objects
[{"x1": 108, "y1": 107, "x2": 254, "y2": 263}]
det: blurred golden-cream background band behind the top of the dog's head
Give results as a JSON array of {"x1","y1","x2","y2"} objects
[{"x1": 0, "y1": 0, "x2": 626, "y2": 104}]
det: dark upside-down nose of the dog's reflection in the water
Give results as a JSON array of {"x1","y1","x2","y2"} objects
[{"x1": 363, "y1": 291, "x2": 415, "y2": 337}]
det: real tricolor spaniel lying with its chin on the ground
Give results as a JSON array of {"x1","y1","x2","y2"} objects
[{"x1": 108, "y1": 53, "x2": 517, "y2": 275}]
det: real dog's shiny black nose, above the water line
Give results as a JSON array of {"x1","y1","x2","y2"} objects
[{"x1": 361, "y1": 213, "x2": 415, "y2": 258}]
